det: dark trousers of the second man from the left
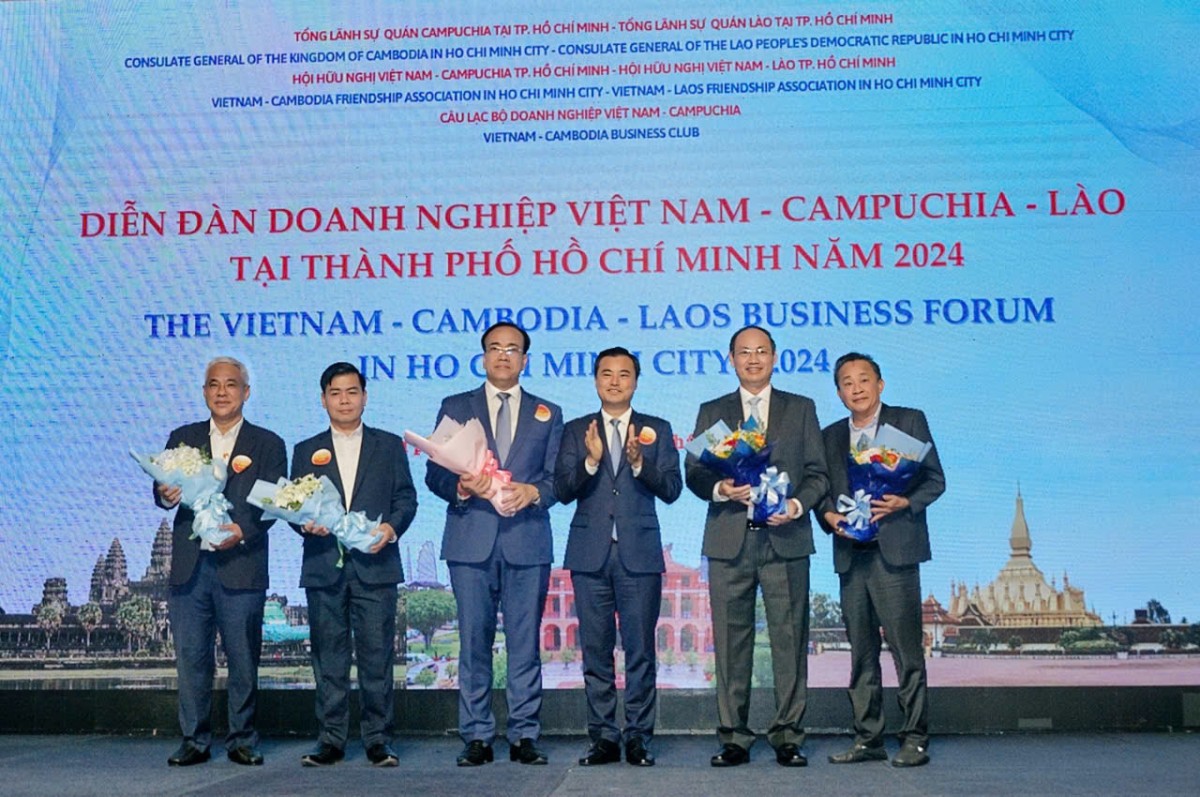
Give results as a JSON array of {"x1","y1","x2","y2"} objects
[{"x1": 305, "y1": 557, "x2": 396, "y2": 749}]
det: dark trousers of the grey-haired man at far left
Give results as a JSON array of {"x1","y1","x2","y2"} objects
[{"x1": 168, "y1": 553, "x2": 266, "y2": 750}]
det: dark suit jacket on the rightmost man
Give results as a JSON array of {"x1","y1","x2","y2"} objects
[{"x1": 817, "y1": 405, "x2": 946, "y2": 573}]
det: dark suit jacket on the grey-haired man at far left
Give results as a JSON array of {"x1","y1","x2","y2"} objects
[{"x1": 154, "y1": 420, "x2": 288, "y2": 591}]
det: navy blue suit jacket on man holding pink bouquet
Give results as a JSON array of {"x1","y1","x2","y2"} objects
[{"x1": 425, "y1": 385, "x2": 563, "y2": 565}]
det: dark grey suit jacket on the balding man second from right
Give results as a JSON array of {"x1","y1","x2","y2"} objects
[{"x1": 686, "y1": 385, "x2": 829, "y2": 559}]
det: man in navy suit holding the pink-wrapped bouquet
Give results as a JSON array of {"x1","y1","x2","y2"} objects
[{"x1": 425, "y1": 322, "x2": 563, "y2": 767}]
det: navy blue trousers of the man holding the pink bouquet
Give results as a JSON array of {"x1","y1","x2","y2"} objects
[{"x1": 446, "y1": 547, "x2": 550, "y2": 744}]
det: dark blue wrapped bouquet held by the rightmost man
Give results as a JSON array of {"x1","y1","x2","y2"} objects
[{"x1": 836, "y1": 424, "x2": 932, "y2": 543}]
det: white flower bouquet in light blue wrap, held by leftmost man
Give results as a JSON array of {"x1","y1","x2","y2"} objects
[{"x1": 130, "y1": 443, "x2": 233, "y2": 551}]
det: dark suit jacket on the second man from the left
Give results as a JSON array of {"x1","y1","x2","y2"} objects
[{"x1": 292, "y1": 425, "x2": 416, "y2": 587}]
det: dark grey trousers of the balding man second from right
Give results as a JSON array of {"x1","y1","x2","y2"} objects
[{"x1": 708, "y1": 529, "x2": 809, "y2": 749}]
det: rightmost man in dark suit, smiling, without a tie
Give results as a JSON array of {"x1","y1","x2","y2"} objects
[{"x1": 817, "y1": 352, "x2": 946, "y2": 767}]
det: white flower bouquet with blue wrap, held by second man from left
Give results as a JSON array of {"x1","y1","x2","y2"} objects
[{"x1": 246, "y1": 473, "x2": 383, "y2": 567}]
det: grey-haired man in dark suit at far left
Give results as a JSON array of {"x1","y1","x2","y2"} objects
[{"x1": 154, "y1": 356, "x2": 288, "y2": 767}]
